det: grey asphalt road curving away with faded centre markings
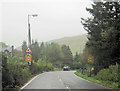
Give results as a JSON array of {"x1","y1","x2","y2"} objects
[{"x1": 23, "y1": 71, "x2": 111, "y2": 91}]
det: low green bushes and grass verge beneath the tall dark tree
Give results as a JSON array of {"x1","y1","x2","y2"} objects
[{"x1": 74, "y1": 64, "x2": 120, "y2": 90}]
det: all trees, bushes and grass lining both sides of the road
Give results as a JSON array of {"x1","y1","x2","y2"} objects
[{"x1": 1, "y1": 1, "x2": 120, "y2": 89}]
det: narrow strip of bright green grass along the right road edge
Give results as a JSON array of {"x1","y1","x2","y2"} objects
[{"x1": 74, "y1": 72, "x2": 120, "y2": 91}]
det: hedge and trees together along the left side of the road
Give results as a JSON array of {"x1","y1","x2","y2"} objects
[{"x1": 0, "y1": 41, "x2": 73, "y2": 90}]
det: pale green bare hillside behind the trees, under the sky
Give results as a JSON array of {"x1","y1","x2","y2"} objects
[{"x1": 50, "y1": 34, "x2": 88, "y2": 55}]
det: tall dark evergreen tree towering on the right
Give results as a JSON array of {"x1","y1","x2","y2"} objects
[{"x1": 82, "y1": 2, "x2": 120, "y2": 72}]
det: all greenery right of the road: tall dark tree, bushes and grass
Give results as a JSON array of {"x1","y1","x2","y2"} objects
[{"x1": 75, "y1": 1, "x2": 120, "y2": 89}]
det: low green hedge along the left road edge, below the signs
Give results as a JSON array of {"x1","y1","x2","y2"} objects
[{"x1": 2, "y1": 54, "x2": 54, "y2": 89}]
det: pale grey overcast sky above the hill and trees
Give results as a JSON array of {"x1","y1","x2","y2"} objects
[{"x1": 0, "y1": 0, "x2": 91, "y2": 47}]
